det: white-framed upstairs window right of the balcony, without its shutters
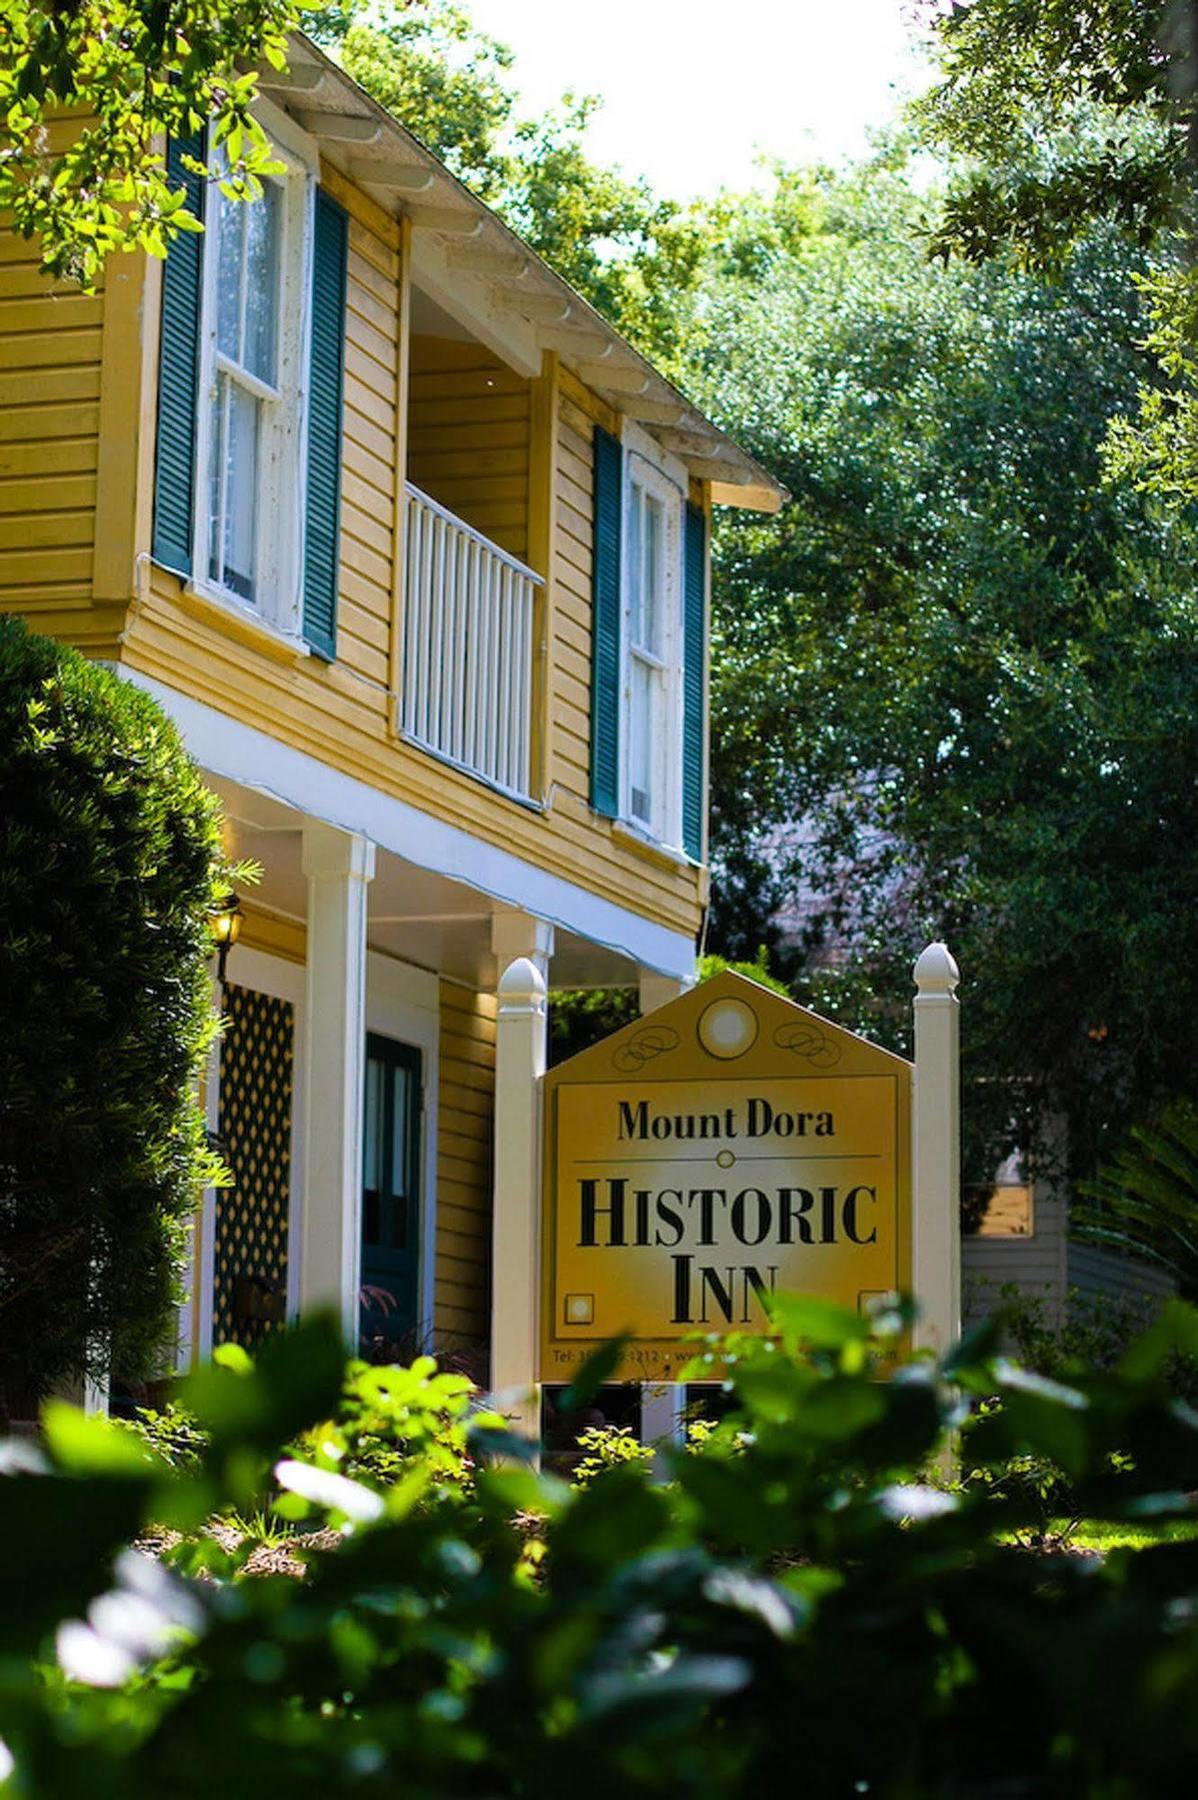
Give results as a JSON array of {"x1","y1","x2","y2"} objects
[{"x1": 621, "y1": 446, "x2": 684, "y2": 846}]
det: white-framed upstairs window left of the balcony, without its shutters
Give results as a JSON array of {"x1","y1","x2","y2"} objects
[{"x1": 192, "y1": 125, "x2": 315, "y2": 632}]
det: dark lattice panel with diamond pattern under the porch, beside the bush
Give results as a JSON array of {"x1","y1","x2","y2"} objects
[{"x1": 212, "y1": 986, "x2": 295, "y2": 1350}]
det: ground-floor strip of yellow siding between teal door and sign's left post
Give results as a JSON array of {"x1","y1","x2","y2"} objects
[{"x1": 434, "y1": 981, "x2": 495, "y2": 1348}]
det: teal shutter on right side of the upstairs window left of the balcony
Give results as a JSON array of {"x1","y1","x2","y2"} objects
[{"x1": 304, "y1": 189, "x2": 349, "y2": 661}]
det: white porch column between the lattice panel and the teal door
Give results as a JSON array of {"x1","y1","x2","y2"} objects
[{"x1": 299, "y1": 819, "x2": 374, "y2": 1346}]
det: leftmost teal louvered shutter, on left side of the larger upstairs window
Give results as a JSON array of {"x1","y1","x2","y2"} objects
[{"x1": 151, "y1": 131, "x2": 203, "y2": 574}]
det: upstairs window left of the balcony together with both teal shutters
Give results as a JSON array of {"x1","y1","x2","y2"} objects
[{"x1": 151, "y1": 101, "x2": 349, "y2": 661}]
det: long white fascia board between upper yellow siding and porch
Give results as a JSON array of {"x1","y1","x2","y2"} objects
[{"x1": 119, "y1": 666, "x2": 694, "y2": 981}]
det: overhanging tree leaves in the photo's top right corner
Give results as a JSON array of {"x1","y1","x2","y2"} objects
[{"x1": 916, "y1": 0, "x2": 1198, "y2": 504}]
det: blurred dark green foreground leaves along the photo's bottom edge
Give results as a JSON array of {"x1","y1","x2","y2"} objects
[{"x1": 0, "y1": 1300, "x2": 1198, "y2": 1800}]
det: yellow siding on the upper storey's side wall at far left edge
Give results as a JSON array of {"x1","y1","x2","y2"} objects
[{"x1": 0, "y1": 232, "x2": 113, "y2": 643}]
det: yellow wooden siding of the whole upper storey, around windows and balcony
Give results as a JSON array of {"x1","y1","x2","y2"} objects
[{"x1": 0, "y1": 171, "x2": 705, "y2": 934}]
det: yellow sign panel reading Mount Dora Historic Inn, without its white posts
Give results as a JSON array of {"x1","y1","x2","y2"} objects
[{"x1": 540, "y1": 972, "x2": 910, "y2": 1381}]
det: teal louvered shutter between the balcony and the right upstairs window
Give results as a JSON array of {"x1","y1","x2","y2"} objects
[{"x1": 590, "y1": 425, "x2": 624, "y2": 819}]
